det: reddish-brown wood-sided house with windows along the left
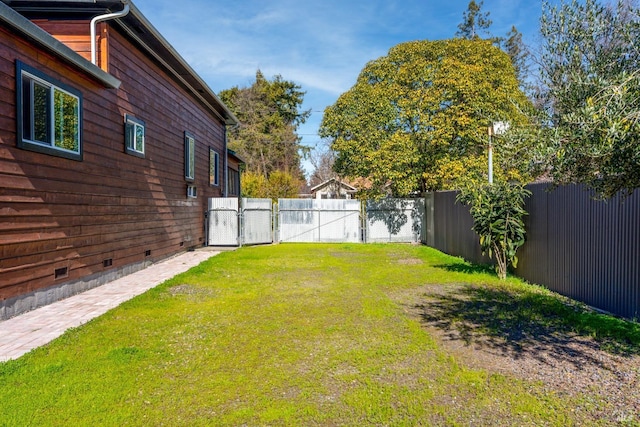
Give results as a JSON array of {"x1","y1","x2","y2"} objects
[{"x1": 0, "y1": 0, "x2": 237, "y2": 319}]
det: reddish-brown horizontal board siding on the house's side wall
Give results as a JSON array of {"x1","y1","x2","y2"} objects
[{"x1": 0, "y1": 20, "x2": 224, "y2": 300}]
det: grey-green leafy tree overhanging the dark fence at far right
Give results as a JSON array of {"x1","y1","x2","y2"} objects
[{"x1": 540, "y1": 0, "x2": 640, "y2": 198}]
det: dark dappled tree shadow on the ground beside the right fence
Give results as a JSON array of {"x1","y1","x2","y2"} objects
[{"x1": 423, "y1": 270, "x2": 640, "y2": 356}]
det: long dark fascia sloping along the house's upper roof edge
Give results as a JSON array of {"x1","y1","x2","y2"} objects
[{"x1": 115, "y1": 2, "x2": 239, "y2": 125}]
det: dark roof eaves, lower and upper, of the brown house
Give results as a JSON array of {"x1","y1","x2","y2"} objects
[{"x1": 0, "y1": 0, "x2": 238, "y2": 125}]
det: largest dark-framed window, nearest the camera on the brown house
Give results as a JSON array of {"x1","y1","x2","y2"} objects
[{"x1": 16, "y1": 61, "x2": 82, "y2": 160}]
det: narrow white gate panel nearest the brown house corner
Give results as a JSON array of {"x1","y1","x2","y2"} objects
[{"x1": 207, "y1": 197, "x2": 239, "y2": 246}]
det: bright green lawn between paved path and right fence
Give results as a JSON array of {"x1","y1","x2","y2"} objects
[{"x1": 0, "y1": 244, "x2": 640, "y2": 426}]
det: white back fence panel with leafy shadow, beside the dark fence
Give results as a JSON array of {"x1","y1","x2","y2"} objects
[{"x1": 366, "y1": 199, "x2": 426, "y2": 243}]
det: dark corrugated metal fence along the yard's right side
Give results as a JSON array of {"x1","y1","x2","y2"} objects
[{"x1": 427, "y1": 184, "x2": 640, "y2": 318}]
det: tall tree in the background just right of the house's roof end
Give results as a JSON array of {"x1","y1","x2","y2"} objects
[{"x1": 219, "y1": 70, "x2": 310, "y2": 178}]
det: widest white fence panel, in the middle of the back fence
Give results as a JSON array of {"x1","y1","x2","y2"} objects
[{"x1": 278, "y1": 199, "x2": 360, "y2": 243}]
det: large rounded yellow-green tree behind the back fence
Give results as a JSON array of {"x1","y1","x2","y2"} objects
[{"x1": 320, "y1": 38, "x2": 530, "y2": 196}]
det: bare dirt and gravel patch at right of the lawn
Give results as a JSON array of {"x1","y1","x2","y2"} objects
[{"x1": 392, "y1": 285, "x2": 640, "y2": 425}]
